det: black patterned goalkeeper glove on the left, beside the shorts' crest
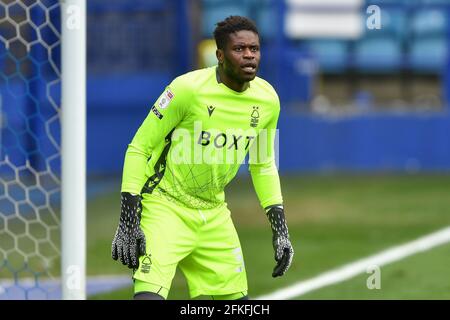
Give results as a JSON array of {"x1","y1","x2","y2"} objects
[{"x1": 111, "y1": 192, "x2": 145, "y2": 269}]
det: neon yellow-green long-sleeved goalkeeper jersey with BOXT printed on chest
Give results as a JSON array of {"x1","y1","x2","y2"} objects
[{"x1": 122, "y1": 66, "x2": 282, "y2": 209}]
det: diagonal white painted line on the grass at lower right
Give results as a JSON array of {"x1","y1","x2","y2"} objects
[{"x1": 256, "y1": 226, "x2": 450, "y2": 300}]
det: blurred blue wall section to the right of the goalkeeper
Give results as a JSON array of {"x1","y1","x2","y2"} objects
[{"x1": 279, "y1": 113, "x2": 450, "y2": 171}]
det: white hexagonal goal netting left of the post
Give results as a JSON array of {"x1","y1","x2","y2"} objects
[{"x1": 0, "y1": 0, "x2": 60, "y2": 299}]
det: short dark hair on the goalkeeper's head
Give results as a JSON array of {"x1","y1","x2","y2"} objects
[{"x1": 214, "y1": 16, "x2": 259, "y2": 49}]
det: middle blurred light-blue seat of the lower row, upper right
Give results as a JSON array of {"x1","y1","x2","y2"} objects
[{"x1": 353, "y1": 37, "x2": 402, "y2": 72}]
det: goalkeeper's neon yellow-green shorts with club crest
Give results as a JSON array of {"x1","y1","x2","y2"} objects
[{"x1": 133, "y1": 193, "x2": 247, "y2": 298}]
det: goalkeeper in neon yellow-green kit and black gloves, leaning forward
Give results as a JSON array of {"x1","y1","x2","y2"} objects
[{"x1": 112, "y1": 16, "x2": 294, "y2": 300}]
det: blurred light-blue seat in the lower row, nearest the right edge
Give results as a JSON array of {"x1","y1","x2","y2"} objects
[{"x1": 409, "y1": 36, "x2": 448, "y2": 73}]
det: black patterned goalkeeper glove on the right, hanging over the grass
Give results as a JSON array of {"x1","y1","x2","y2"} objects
[{"x1": 266, "y1": 205, "x2": 294, "y2": 278}]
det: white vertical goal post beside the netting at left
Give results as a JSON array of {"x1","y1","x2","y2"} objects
[{"x1": 61, "y1": 0, "x2": 86, "y2": 300}]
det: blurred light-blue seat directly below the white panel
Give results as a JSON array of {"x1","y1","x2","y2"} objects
[{"x1": 307, "y1": 39, "x2": 348, "y2": 73}]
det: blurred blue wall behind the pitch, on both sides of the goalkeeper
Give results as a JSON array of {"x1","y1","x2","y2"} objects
[{"x1": 87, "y1": 74, "x2": 450, "y2": 174}]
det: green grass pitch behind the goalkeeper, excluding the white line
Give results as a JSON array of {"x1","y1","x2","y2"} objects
[{"x1": 87, "y1": 174, "x2": 450, "y2": 299}]
